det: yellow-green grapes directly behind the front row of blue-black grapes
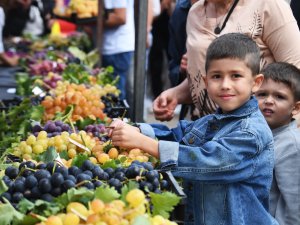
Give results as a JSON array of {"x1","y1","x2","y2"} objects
[{"x1": 13, "y1": 131, "x2": 96, "y2": 163}]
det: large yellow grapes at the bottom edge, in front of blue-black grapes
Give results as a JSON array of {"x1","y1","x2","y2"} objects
[{"x1": 36, "y1": 189, "x2": 177, "y2": 225}]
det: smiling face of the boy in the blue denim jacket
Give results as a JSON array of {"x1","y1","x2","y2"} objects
[{"x1": 204, "y1": 58, "x2": 263, "y2": 113}]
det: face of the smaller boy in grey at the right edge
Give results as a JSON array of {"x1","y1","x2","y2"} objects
[{"x1": 255, "y1": 79, "x2": 299, "y2": 129}]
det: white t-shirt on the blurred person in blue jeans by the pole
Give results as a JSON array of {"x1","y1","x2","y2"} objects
[{"x1": 102, "y1": 0, "x2": 135, "y2": 55}]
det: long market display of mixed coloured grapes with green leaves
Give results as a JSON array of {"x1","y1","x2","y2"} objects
[{"x1": 0, "y1": 32, "x2": 184, "y2": 225}]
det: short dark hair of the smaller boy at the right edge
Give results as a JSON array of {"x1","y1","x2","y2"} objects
[{"x1": 261, "y1": 62, "x2": 300, "y2": 101}]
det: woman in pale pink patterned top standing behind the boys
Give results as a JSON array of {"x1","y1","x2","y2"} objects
[{"x1": 153, "y1": 0, "x2": 300, "y2": 121}]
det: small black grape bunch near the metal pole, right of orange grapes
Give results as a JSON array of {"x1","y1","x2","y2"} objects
[{"x1": 101, "y1": 93, "x2": 128, "y2": 118}]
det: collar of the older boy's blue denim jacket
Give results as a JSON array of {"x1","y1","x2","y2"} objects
[{"x1": 214, "y1": 96, "x2": 258, "y2": 120}]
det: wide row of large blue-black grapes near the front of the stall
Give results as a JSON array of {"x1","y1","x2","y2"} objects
[{"x1": 1, "y1": 160, "x2": 169, "y2": 204}]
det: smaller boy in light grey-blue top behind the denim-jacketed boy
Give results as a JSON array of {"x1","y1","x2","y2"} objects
[{"x1": 255, "y1": 63, "x2": 300, "y2": 225}]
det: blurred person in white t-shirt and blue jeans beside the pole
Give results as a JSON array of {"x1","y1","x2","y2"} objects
[{"x1": 102, "y1": 0, "x2": 135, "y2": 99}]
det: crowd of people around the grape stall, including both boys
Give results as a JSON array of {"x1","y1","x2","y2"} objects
[{"x1": 0, "y1": 0, "x2": 300, "y2": 225}]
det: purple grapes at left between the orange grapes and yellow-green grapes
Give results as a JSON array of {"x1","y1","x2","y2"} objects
[{"x1": 32, "y1": 120, "x2": 73, "y2": 138}]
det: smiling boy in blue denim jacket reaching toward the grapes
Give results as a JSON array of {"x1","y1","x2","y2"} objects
[{"x1": 110, "y1": 33, "x2": 277, "y2": 225}]
